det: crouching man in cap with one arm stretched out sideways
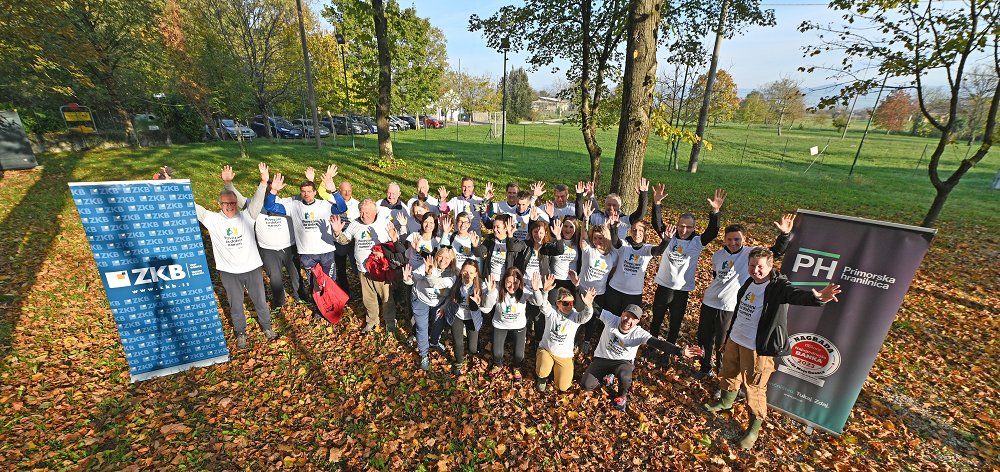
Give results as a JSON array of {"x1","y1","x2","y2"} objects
[{"x1": 580, "y1": 304, "x2": 702, "y2": 411}]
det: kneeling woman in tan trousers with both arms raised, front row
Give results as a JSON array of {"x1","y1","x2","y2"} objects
[{"x1": 535, "y1": 275, "x2": 597, "y2": 392}]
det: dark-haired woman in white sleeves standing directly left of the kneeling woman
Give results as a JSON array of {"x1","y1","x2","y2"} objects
[{"x1": 482, "y1": 267, "x2": 532, "y2": 382}]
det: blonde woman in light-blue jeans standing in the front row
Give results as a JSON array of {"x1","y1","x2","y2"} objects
[{"x1": 403, "y1": 247, "x2": 458, "y2": 370}]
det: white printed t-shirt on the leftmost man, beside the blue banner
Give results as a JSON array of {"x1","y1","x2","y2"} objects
[{"x1": 199, "y1": 211, "x2": 264, "y2": 274}]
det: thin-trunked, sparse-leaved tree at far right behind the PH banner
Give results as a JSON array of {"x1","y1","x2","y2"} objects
[{"x1": 799, "y1": 0, "x2": 1000, "y2": 227}]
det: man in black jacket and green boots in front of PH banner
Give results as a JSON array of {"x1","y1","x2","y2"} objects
[{"x1": 702, "y1": 248, "x2": 840, "y2": 449}]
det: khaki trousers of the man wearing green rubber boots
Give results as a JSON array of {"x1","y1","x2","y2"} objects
[{"x1": 719, "y1": 340, "x2": 774, "y2": 420}]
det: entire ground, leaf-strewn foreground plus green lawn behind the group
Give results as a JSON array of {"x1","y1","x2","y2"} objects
[{"x1": 0, "y1": 121, "x2": 1000, "y2": 470}]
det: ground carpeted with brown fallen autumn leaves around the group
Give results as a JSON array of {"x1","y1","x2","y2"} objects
[{"x1": 0, "y1": 135, "x2": 1000, "y2": 470}]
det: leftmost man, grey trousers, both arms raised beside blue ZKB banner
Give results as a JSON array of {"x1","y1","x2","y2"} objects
[{"x1": 195, "y1": 162, "x2": 278, "y2": 349}]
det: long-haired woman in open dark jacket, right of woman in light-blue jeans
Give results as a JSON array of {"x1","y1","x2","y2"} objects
[{"x1": 429, "y1": 260, "x2": 488, "y2": 375}]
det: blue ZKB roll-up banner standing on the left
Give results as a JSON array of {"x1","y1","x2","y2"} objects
[{"x1": 69, "y1": 180, "x2": 229, "y2": 382}]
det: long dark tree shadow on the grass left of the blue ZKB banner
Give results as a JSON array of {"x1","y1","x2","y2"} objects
[{"x1": 0, "y1": 153, "x2": 81, "y2": 369}]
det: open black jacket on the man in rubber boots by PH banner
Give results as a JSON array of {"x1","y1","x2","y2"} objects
[{"x1": 726, "y1": 270, "x2": 825, "y2": 356}]
